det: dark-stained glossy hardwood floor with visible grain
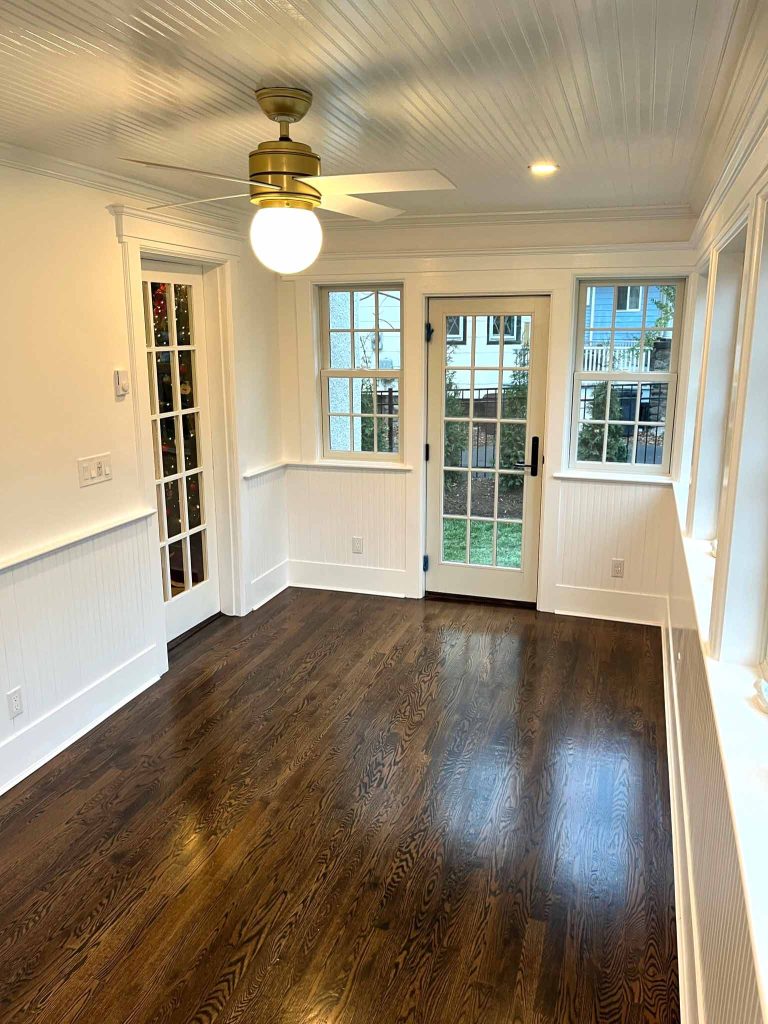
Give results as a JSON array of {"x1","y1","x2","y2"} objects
[{"x1": 0, "y1": 590, "x2": 679, "y2": 1024}]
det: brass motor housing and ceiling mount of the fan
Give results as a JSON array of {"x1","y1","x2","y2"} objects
[{"x1": 248, "y1": 86, "x2": 322, "y2": 210}]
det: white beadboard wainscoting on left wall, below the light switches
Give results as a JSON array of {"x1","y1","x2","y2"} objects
[{"x1": 0, "y1": 513, "x2": 168, "y2": 792}]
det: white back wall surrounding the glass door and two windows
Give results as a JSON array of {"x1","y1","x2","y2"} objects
[{"x1": 280, "y1": 243, "x2": 693, "y2": 623}]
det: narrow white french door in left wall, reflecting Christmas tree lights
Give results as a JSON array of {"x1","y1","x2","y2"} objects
[{"x1": 142, "y1": 263, "x2": 221, "y2": 640}]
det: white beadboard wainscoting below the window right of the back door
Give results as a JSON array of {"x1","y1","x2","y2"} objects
[{"x1": 539, "y1": 473, "x2": 673, "y2": 625}]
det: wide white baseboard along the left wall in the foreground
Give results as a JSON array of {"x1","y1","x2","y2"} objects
[{"x1": 0, "y1": 644, "x2": 163, "y2": 794}]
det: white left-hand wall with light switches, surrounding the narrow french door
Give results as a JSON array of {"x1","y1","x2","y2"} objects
[{"x1": 0, "y1": 158, "x2": 286, "y2": 792}]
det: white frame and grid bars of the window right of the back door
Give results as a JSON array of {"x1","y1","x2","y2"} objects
[{"x1": 568, "y1": 275, "x2": 686, "y2": 478}]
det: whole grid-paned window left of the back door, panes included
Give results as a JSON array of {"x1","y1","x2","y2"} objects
[{"x1": 321, "y1": 285, "x2": 402, "y2": 460}]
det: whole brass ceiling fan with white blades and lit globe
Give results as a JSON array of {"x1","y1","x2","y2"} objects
[{"x1": 126, "y1": 86, "x2": 456, "y2": 273}]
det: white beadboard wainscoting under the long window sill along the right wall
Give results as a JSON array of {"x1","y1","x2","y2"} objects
[{"x1": 664, "y1": 518, "x2": 764, "y2": 1024}]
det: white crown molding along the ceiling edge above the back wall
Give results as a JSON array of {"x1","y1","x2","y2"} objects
[{"x1": 325, "y1": 203, "x2": 695, "y2": 234}]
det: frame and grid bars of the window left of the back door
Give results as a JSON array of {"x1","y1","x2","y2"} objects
[{"x1": 317, "y1": 282, "x2": 404, "y2": 465}]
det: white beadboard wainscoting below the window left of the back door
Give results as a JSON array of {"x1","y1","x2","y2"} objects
[{"x1": 288, "y1": 465, "x2": 419, "y2": 597}]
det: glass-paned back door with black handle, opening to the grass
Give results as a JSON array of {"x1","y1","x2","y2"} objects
[{"x1": 427, "y1": 296, "x2": 549, "y2": 601}]
